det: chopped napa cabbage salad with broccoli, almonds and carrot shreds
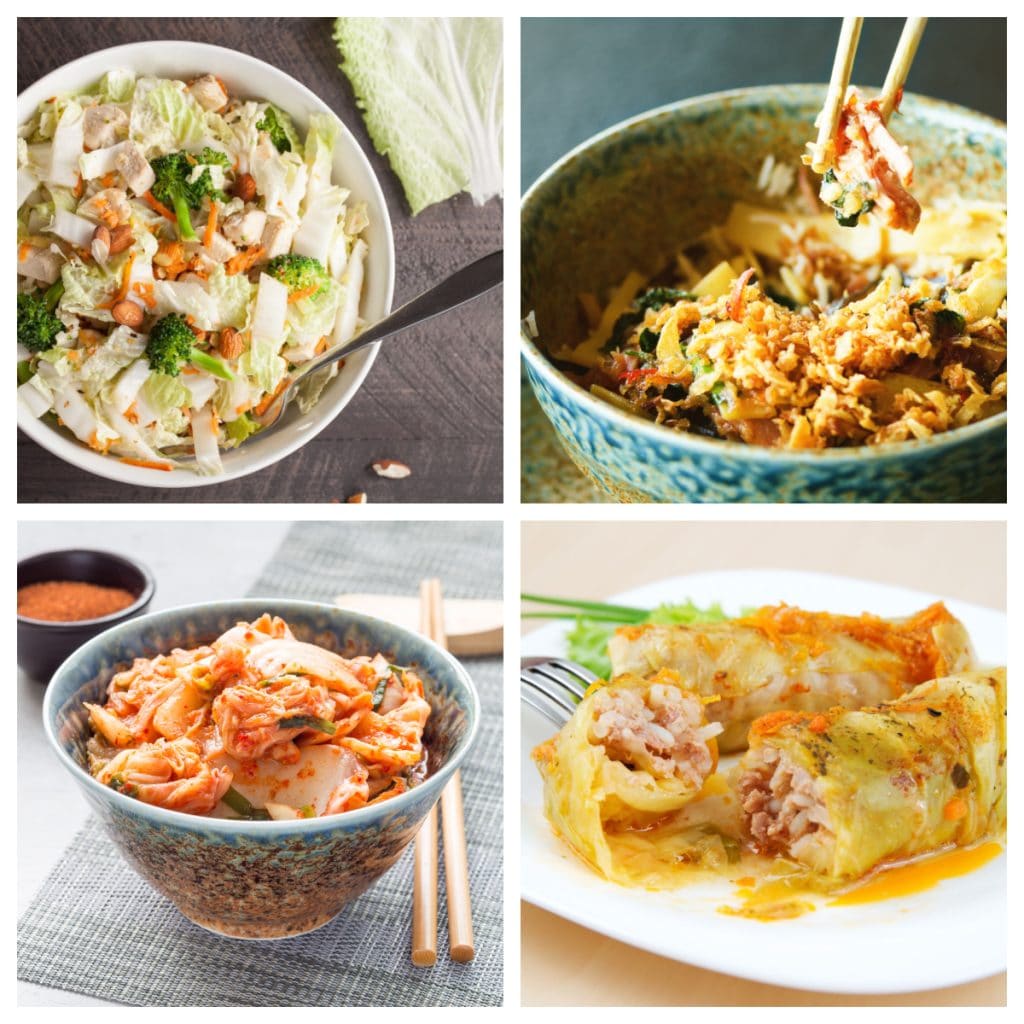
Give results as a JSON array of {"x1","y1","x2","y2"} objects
[{"x1": 17, "y1": 70, "x2": 369, "y2": 474}]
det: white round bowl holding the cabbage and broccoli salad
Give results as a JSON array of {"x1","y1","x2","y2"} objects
[{"x1": 17, "y1": 40, "x2": 394, "y2": 487}]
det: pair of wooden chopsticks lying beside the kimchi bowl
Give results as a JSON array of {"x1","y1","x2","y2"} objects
[{"x1": 413, "y1": 580, "x2": 475, "y2": 967}]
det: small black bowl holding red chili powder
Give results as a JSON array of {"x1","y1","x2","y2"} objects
[{"x1": 17, "y1": 550, "x2": 157, "y2": 682}]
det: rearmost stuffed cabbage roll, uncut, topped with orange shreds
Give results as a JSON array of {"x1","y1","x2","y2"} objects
[{"x1": 608, "y1": 603, "x2": 972, "y2": 754}]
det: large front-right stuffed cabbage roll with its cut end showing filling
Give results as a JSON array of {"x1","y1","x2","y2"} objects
[{"x1": 738, "y1": 669, "x2": 1007, "y2": 881}]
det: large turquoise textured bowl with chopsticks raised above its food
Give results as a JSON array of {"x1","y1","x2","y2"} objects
[{"x1": 521, "y1": 85, "x2": 1007, "y2": 502}]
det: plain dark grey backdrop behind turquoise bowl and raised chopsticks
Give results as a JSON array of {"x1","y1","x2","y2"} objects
[{"x1": 521, "y1": 17, "x2": 1007, "y2": 188}]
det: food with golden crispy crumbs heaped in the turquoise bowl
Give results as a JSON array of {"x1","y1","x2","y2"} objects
[{"x1": 596, "y1": 247, "x2": 1007, "y2": 449}]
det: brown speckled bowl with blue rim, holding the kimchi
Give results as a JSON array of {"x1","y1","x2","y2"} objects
[{"x1": 43, "y1": 598, "x2": 480, "y2": 939}]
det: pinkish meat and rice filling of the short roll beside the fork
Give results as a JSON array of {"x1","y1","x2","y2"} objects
[{"x1": 590, "y1": 684, "x2": 721, "y2": 788}]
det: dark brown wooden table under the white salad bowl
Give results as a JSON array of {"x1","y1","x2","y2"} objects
[{"x1": 17, "y1": 17, "x2": 502, "y2": 503}]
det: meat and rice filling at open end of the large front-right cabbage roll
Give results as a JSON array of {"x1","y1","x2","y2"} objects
[{"x1": 739, "y1": 746, "x2": 834, "y2": 860}]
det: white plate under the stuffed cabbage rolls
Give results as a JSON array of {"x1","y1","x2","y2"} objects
[{"x1": 521, "y1": 570, "x2": 1007, "y2": 994}]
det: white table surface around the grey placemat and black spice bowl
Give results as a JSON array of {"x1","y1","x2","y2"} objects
[{"x1": 17, "y1": 522, "x2": 291, "y2": 1007}]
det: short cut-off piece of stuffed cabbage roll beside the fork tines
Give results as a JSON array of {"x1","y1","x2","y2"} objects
[{"x1": 534, "y1": 670, "x2": 721, "y2": 878}]
